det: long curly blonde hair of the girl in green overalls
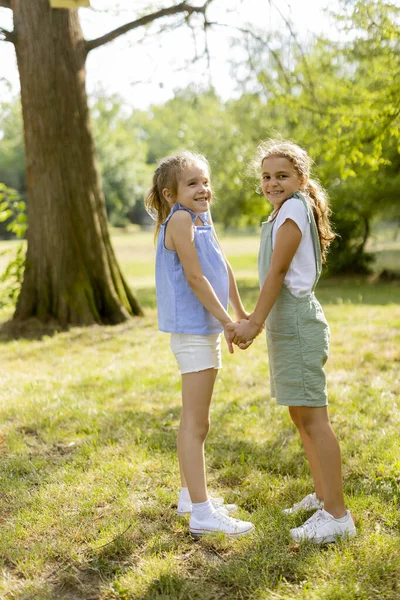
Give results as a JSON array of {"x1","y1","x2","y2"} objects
[{"x1": 254, "y1": 139, "x2": 336, "y2": 263}]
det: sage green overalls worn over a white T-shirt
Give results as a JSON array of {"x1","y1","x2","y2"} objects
[{"x1": 258, "y1": 192, "x2": 330, "y2": 406}]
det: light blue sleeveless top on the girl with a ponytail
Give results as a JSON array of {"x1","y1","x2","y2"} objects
[{"x1": 156, "y1": 203, "x2": 229, "y2": 335}]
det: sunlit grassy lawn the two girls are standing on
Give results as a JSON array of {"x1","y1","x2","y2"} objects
[{"x1": 0, "y1": 232, "x2": 400, "y2": 600}]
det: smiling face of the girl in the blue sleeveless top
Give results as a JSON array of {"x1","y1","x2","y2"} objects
[{"x1": 163, "y1": 162, "x2": 212, "y2": 214}]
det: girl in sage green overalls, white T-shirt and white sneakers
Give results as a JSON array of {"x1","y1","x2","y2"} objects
[{"x1": 229, "y1": 140, "x2": 356, "y2": 543}]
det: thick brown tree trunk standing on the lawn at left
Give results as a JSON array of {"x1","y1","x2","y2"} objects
[{"x1": 12, "y1": 0, "x2": 142, "y2": 326}]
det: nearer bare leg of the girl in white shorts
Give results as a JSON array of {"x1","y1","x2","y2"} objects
[{"x1": 178, "y1": 369, "x2": 218, "y2": 503}]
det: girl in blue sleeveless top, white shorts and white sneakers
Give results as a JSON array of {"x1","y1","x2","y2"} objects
[{"x1": 145, "y1": 152, "x2": 254, "y2": 536}]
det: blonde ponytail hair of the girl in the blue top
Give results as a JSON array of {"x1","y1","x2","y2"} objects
[{"x1": 144, "y1": 150, "x2": 210, "y2": 237}]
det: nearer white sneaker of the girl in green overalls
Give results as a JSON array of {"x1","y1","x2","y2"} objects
[{"x1": 290, "y1": 509, "x2": 357, "y2": 544}]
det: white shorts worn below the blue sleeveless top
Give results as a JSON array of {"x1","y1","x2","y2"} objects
[{"x1": 171, "y1": 333, "x2": 222, "y2": 375}]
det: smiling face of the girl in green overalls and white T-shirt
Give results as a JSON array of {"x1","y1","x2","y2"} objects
[{"x1": 261, "y1": 156, "x2": 307, "y2": 209}]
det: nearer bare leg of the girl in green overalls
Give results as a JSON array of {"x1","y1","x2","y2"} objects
[{"x1": 298, "y1": 406, "x2": 346, "y2": 518}]
